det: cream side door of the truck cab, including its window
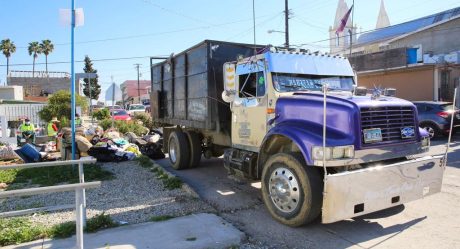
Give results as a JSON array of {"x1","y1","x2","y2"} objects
[{"x1": 232, "y1": 61, "x2": 267, "y2": 152}]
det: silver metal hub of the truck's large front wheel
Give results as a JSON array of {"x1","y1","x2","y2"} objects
[{"x1": 268, "y1": 168, "x2": 300, "y2": 213}]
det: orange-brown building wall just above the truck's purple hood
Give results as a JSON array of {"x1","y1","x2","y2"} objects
[{"x1": 358, "y1": 67, "x2": 434, "y2": 101}]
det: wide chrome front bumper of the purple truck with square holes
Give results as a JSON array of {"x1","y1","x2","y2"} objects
[{"x1": 322, "y1": 156, "x2": 444, "y2": 223}]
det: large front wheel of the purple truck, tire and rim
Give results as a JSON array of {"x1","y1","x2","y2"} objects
[{"x1": 262, "y1": 153, "x2": 323, "y2": 227}]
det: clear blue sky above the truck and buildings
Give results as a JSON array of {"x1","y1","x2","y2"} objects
[{"x1": 0, "y1": 0, "x2": 460, "y2": 100}]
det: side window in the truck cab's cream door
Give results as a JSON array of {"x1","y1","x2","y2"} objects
[{"x1": 238, "y1": 72, "x2": 265, "y2": 98}]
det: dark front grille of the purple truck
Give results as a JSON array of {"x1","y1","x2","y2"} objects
[{"x1": 361, "y1": 106, "x2": 417, "y2": 146}]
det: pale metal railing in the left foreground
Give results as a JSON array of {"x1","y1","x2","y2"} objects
[{"x1": 0, "y1": 159, "x2": 101, "y2": 249}]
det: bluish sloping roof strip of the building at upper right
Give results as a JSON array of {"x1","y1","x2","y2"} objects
[{"x1": 355, "y1": 7, "x2": 460, "y2": 46}]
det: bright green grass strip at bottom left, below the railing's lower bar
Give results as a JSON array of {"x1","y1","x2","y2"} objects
[{"x1": 0, "y1": 213, "x2": 118, "y2": 246}]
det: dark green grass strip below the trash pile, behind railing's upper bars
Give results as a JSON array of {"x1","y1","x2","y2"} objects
[{"x1": 0, "y1": 164, "x2": 114, "y2": 190}]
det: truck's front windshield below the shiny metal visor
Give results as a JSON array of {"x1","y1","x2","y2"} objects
[{"x1": 272, "y1": 73, "x2": 353, "y2": 92}]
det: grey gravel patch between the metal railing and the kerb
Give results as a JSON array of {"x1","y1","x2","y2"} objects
[{"x1": 0, "y1": 161, "x2": 215, "y2": 226}]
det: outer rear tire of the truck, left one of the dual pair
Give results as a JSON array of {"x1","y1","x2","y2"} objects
[{"x1": 168, "y1": 130, "x2": 190, "y2": 170}]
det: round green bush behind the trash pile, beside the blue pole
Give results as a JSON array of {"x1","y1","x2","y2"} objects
[{"x1": 38, "y1": 90, "x2": 87, "y2": 122}]
